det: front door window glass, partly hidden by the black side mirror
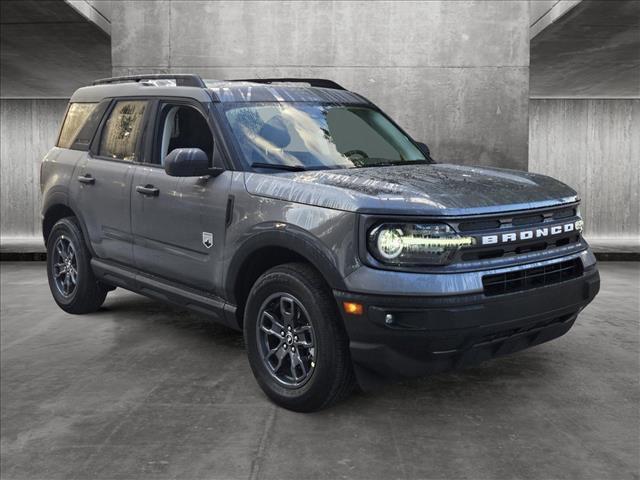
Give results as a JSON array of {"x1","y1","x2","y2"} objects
[{"x1": 153, "y1": 104, "x2": 213, "y2": 166}]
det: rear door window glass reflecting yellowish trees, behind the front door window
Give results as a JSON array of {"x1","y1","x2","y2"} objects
[{"x1": 98, "y1": 100, "x2": 147, "y2": 161}]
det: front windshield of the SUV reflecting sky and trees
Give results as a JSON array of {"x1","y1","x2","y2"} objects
[{"x1": 226, "y1": 103, "x2": 429, "y2": 170}]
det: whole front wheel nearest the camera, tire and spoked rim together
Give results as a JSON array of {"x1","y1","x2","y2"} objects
[{"x1": 244, "y1": 263, "x2": 355, "y2": 412}]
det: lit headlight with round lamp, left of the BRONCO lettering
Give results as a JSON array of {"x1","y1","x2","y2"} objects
[{"x1": 367, "y1": 223, "x2": 475, "y2": 265}]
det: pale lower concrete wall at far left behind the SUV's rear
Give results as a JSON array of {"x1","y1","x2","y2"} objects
[{"x1": 0, "y1": 99, "x2": 67, "y2": 245}]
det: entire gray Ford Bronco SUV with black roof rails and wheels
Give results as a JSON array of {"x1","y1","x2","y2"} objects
[{"x1": 41, "y1": 75, "x2": 599, "y2": 411}]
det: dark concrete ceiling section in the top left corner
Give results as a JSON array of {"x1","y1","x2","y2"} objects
[{"x1": 0, "y1": 0, "x2": 111, "y2": 98}]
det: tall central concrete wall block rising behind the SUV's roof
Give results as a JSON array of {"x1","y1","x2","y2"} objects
[{"x1": 111, "y1": 0, "x2": 529, "y2": 169}]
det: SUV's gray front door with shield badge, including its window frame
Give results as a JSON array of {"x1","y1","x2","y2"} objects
[{"x1": 131, "y1": 102, "x2": 231, "y2": 293}]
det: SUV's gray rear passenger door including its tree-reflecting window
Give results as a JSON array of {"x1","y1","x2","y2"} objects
[{"x1": 73, "y1": 98, "x2": 149, "y2": 266}]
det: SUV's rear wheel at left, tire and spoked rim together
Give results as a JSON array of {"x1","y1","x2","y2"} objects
[{"x1": 47, "y1": 217, "x2": 108, "y2": 314}]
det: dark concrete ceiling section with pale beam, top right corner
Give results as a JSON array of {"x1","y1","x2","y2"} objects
[{"x1": 530, "y1": 0, "x2": 640, "y2": 98}]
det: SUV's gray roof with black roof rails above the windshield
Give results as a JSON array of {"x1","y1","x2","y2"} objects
[{"x1": 71, "y1": 75, "x2": 369, "y2": 104}]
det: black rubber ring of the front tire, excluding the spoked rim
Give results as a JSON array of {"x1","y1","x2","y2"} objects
[{"x1": 244, "y1": 269, "x2": 344, "y2": 409}]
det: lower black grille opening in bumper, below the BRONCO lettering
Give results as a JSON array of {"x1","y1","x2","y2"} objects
[{"x1": 482, "y1": 258, "x2": 582, "y2": 296}]
